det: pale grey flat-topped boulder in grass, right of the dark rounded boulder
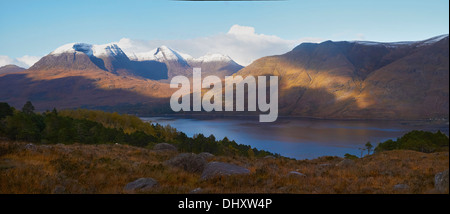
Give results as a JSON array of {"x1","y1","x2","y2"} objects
[{"x1": 201, "y1": 162, "x2": 250, "y2": 180}]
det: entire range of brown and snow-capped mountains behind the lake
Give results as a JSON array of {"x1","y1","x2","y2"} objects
[{"x1": 0, "y1": 35, "x2": 449, "y2": 119}]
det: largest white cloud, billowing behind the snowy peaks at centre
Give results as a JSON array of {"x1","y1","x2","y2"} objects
[{"x1": 118, "y1": 25, "x2": 323, "y2": 66}]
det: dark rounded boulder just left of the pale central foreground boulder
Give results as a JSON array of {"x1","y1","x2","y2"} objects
[{"x1": 166, "y1": 153, "x2": 207, "y2": 173}]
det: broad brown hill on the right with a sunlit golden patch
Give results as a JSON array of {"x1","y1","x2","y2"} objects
[{"x1": 236, "y1": 35, "x2": 449, "y2": 119}]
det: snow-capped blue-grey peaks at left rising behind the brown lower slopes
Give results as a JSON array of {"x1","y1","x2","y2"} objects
[{"x1": 30, "y1": 43, "x2": 242, "y2": 81}]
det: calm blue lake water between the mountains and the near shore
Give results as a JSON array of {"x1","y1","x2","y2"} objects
[{"x1": 141, "y1": 117, "x2": 449, "y2": 159}]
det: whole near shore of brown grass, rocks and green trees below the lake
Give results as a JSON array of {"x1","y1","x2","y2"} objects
[{"x1": 0, "y1": 103, "x2": 449, "y2": 194}]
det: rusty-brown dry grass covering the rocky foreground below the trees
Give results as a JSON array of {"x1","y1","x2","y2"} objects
[{"x1": 0, "y1": 142, "x2": 449, "y2": 194}]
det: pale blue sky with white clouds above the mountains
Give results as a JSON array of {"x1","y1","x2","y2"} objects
[{"x1": 0, "y1": 0, "x2": 449, "y2": 67}]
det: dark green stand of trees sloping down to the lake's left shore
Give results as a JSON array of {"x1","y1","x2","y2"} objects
[{"x1": 0, "y1": 102, "x2": 279, "y2": 157}]
